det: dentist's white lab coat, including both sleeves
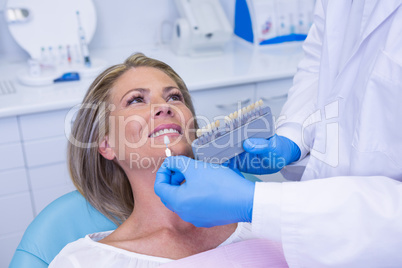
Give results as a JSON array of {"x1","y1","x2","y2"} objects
[{"x1": 253, "y1": 0, "x2": 402, "y2": 267}]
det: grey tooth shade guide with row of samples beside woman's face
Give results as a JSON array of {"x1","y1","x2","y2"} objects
[{"x1": 191, "y1": 100, "x2": 275, "y2": 164}]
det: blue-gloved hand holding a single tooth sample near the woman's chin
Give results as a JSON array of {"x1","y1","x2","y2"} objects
[{"x1": 154, "y1": 156, "x2": 255, "y2": 227}]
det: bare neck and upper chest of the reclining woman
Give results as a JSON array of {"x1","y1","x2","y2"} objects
[{"x1": 100, "y1": 165, "x2": 237, "y2": 259}]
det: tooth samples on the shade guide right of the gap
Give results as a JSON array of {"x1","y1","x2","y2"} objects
[{"x1": 225, "y1": 100, "x2": 264, "y2": 128}]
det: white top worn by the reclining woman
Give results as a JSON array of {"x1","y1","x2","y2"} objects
[{"x1": 49, "y1": 223, "x2": 256, "y2": 268}]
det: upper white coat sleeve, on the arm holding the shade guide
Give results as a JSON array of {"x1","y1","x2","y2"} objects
[{"x1": 276, "y1": 1, "x2": 325, "y2": 159}]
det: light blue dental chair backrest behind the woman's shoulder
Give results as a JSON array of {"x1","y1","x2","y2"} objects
[{"x1": 9, "y1": 191, "x2": 116, "y2": 268}]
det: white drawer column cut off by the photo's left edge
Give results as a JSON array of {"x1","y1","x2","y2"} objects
[{"x1": 0, "y1": 116, "x2": 34, "y2": 267}]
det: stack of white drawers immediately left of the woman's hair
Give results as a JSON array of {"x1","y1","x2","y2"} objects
[{"x1": 19, "y1": 109, "x2": 74, "y2": 215}]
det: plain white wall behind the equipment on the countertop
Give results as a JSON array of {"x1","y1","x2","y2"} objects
[{"x1": 0, "y1": 0, "x2": 235, "y2": 61}]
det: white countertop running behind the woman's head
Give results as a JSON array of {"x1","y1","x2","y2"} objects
[{"x1": 0, "y1": 42, "x2": 303, "y2": 118}]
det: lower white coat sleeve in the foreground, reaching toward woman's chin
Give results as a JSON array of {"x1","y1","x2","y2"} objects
[{"x1": 252, "y1": 177, "x2": 402, "y2": 267}]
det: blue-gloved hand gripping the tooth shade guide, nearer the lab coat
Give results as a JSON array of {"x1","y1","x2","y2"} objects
[{"x1": 224, "y1": 134, "x2": 300, "y2": 175}]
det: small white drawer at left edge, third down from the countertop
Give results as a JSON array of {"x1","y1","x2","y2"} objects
[{"x1": 0, "y1": 168, "x2": 29, "y2": 196}]
